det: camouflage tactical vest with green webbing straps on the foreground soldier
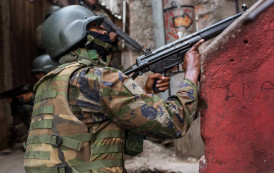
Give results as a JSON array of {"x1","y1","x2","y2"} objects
[{"x1": 24, "y1": 63, "x2": 125, "y2": 173}]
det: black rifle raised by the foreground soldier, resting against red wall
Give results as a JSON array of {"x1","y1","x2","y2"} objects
[{"x1": 124, "y1": 5, "x2": 247, "y2": 92}]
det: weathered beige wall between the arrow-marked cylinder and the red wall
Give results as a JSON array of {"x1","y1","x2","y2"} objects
[{"x1": 170, "y1": 0, "x2": 256, "y2": 159}]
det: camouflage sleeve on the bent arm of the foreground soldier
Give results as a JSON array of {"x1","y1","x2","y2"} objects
[{"x1": 100, "y1": 68, "x2": 198, "y2": 139}]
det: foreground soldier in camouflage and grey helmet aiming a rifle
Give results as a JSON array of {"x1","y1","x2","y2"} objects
[{"x1": 24, "y1": 5, "x2": 203, "y2": 173}]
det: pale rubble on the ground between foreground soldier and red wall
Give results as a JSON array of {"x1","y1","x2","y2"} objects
[{"x1": 125, "y1": 140, "x2": 199, "y2": 173}]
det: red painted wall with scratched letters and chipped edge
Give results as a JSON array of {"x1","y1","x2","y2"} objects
[{"x1": 200, "y1": 2, "x2": 274, "y2": 173}]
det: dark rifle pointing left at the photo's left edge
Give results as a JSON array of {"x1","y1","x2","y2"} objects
[{"x1": 0, "y1": 84, "x2": 32, "y2": 99}]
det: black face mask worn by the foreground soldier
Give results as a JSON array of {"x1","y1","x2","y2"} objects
[{"x1": 89, "y1": 31, "x2": 112, "y2": 61}]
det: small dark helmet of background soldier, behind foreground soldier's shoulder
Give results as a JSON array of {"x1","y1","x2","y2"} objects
[{"x1": 31, "y1": 54, "x2": 59, "y2": 73}]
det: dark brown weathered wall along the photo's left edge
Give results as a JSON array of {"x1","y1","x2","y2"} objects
[{"x1": 0, "y1": 0, "x2": 48, "y2": 150}]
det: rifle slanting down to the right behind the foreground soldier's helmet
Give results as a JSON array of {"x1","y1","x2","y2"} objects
[{"x1": 79, "y1": 0, "x2": 143, "y2": 51}]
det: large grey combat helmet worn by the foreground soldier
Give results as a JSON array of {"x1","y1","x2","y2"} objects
[{"x1": 42, "y1": 5, "x2": 104, "y2": 61}]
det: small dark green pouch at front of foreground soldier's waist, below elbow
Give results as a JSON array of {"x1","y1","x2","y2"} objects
[{"x1": 125, "y1": 130, "x2": 144, "y2": 156}]
